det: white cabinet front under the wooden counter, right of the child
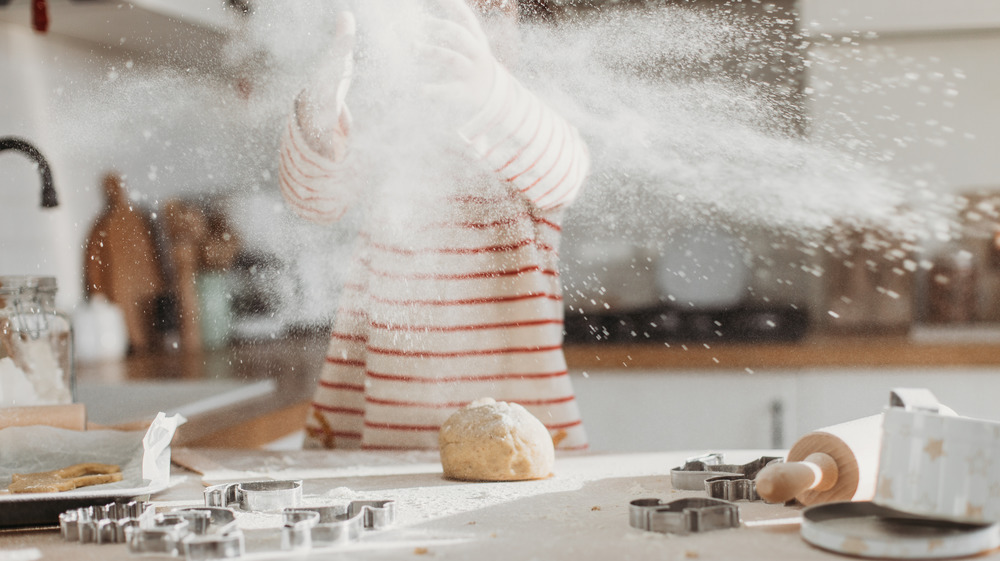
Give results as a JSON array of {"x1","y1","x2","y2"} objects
[{"x1": 572, "y1": 367, "x2": 1000, "y2": 452}]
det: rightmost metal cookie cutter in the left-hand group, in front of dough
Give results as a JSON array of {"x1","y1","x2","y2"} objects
[{"x1": 281, "y1": 500, "x2": 396, "y2": 550}]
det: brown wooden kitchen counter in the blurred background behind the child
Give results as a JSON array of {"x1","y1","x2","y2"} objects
[{"x1": 78, "y1": 334, "x2": 1000, "y2": 448}]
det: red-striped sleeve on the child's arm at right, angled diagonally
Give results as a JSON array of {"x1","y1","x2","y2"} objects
[{"x1": 459, "y1": 64, "x2": 590, "y2": 209}]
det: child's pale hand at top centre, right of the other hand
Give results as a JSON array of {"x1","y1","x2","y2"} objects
[{"x1": 417, "y1": 0, "x2": 496, "y2": 123}]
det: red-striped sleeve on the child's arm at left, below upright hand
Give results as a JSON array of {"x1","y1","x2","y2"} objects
[{"x1": 278, "y1": 107, "x2": 360, "y2": 223}]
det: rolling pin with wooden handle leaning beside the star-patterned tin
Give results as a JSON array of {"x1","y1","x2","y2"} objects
[{"x1": 755, "y1": 414, "x2": 882, "y2": 505}]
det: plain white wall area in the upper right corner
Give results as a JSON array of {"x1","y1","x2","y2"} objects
[{"x1": 800, "y1": 0, "x2": 1000, "y2": 192}]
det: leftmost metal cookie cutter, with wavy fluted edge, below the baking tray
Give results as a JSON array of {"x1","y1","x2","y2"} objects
[{"x1": 59, "y1": 501, "x2": 153, "y2": 544}]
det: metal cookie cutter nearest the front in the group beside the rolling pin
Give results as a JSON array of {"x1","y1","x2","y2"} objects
[{"x1": 628, "y1": 497, "x2": 740, "y2": 534}]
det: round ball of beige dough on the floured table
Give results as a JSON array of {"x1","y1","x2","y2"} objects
[{"x1": 438, "y1": 397, "x2": 555, "y2": 481}]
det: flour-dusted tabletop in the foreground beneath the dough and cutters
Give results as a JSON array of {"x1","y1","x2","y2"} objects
[{"x1": 7, "y1": 449, "x2": 1000, "y2": 561}]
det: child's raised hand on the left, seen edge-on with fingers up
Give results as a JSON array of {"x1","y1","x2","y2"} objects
[{"x1": 296, "y1": 11, "x2": 357, "y2": 159}]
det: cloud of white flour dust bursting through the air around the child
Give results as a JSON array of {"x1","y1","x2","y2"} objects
[{"x1": 52, "y1": 0, "x2": 968, "y2": 322}]
